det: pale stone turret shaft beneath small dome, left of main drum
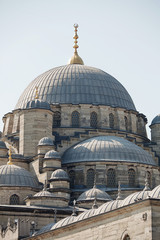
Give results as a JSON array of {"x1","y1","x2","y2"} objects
[{"x1": 19, "y1": 109, "x2": 53, "y2": 156}]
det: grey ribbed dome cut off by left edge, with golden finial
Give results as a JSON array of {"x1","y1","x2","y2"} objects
[{"x1": 0, "y1": 165, "x2": 39, "y2": 188}]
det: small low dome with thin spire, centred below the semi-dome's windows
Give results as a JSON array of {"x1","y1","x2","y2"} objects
[{"x1": 77, "y1": 187, "x2": 112, "y2": 203}]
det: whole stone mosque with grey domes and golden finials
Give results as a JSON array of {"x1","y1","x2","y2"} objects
[{"x1": 0, "y1": 24, "x2": 160, "y2": 240}]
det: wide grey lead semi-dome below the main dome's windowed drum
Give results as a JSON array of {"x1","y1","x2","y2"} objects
[{"x1": 62, "y1": 136, "x2": 156, "y2": 165}]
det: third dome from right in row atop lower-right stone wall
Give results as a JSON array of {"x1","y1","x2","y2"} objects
[{"x1": 96, "y1": 200, "x2": 123, "y2": 214}]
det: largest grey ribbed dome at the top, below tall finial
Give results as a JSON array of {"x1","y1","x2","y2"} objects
[{"x1": 15, "y1": 64, "x2": 136, "y2": 110}]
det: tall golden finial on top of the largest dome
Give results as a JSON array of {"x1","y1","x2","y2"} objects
[{"x1": 69, "y1": 23, "x2": 84, "y2": 65}]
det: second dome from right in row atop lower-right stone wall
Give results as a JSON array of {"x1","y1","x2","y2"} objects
[{"x1": 121, "y1": 190, "x2": 151, "y2": 207}]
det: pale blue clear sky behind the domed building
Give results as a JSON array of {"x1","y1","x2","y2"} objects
[{"x1": 0, "y1": 0, "x2": 160, "y2": 138}]
